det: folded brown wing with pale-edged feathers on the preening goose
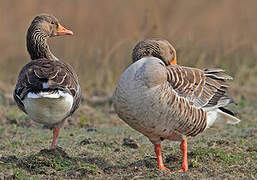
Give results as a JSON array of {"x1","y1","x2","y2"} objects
[{"x1": 167, "y1": 65, "x2": 233, "y2": 108}]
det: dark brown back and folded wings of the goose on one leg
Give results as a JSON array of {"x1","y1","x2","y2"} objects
[{"x1": 13, "y1": 59, "x2": 81, "y2": 113}]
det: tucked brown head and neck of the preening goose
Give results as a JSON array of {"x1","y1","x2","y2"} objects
[{"x1": 132, "y1": 39, "x2": 177, "y2": 66}]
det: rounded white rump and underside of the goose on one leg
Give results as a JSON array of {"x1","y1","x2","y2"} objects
[{"x1": 23, "y1": 91, "x2": 73, "y2": 125}]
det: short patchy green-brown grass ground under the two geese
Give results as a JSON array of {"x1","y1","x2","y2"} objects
[{"x1": 0, "y1": 92, "x2": 257, "y2": 179}]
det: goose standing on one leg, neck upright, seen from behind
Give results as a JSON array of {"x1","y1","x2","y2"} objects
[{"x1": 13, "y1": 14, "x2": 81, "y2": 149}]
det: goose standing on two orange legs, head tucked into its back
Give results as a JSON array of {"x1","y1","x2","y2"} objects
[{"x1": 112, "y1": 39, "x2": 240, "y2": 172}]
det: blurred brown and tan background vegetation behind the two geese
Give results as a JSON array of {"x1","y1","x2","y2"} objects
[{"x1": 0, "y1": 0, "x2": 257, "y2": 112}]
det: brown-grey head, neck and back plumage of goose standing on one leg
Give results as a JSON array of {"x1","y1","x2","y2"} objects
[{"x1": 13, "y1": 14, "x2": 81, "y2": 126}]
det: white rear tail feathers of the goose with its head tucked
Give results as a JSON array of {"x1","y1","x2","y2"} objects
[{"x1": 207, "y1": 109, "x2": 240, "y2": 128}]
